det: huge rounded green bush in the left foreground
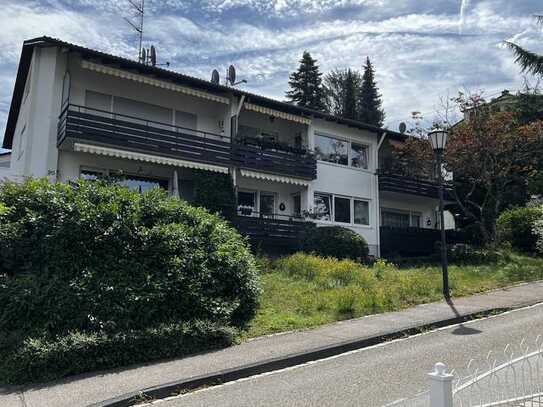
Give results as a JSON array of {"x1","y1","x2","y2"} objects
[{"x1": 0, "y1": 179, "x2": 259, "y2": 382}]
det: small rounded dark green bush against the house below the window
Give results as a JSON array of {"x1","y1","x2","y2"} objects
[{"x1": 302, "y1": 226, "x2": 368, "y2": 261}]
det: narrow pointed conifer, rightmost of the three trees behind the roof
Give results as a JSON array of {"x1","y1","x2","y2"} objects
[{"x1": 358, "y1": 58, "x2": 385, "y2": 127}]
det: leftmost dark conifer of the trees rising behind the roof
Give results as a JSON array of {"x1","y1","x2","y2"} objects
[{"x1": 286, "y1": 51, "x2": 326, "y2": 111}]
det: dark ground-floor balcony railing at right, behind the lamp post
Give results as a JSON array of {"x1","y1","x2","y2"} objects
[{"x1": 380, "y1": 226, "x2": 465, "y2": 257}]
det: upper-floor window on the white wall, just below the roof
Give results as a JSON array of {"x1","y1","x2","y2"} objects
[{"x1": 315, "y1": 134, "x2": 369, "y2": 169}]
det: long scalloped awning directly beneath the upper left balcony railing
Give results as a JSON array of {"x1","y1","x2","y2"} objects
[{"x1": 74, "y1": 143, "x2": 228, "y2": 174}]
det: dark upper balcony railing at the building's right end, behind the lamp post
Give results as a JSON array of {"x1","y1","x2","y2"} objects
[{"x1": 377, "y1": 170, "x2": 451, "y2": 199}]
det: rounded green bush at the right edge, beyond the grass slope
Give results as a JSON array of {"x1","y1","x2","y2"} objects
[{"x1": 497, "y1": 206, "x2": 543, "y2": 253}]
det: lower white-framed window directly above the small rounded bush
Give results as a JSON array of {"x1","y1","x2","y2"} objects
[{"x1": 313, "y1": 192, "x2": 370, "y2": 226}]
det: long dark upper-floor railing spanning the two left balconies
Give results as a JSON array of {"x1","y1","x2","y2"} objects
[{"x1": 57, "y1": 104, "x2": 317, "y2": 179}]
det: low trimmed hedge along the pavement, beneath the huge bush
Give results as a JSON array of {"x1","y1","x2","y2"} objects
[{"x1": 0, "y1": 322, "x2": 237, "y2": 384}]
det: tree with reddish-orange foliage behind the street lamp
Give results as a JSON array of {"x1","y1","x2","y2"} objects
[{"x1": 394, "y1": 95, "x2": 543, "y2": 243}]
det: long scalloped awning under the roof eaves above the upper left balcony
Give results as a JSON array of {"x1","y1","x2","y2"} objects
[{"x1": 81, "y1": 60, "x2": 230, "y2": 104}]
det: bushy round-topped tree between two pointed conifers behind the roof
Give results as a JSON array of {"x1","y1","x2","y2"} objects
[{"x1": 324, "y1": 68, "x2": 362, "y2": 120}]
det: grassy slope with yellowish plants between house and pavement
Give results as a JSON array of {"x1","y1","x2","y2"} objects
[{"x1": 246, "y1": 253, "x2": 543, "y2": 337}]
